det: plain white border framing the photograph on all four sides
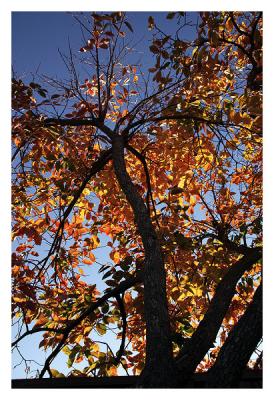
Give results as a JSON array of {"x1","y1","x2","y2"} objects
[{"x1": 0, "y1": 0, "x2": 274, "y2": 399}]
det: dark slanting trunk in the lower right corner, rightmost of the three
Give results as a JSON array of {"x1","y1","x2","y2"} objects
[{"x1": 209, "y1": 284, "x2": 262, "y2": 388}]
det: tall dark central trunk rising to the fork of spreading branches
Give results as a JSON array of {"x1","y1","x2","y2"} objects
[{"x1": 112, "y1": 135, "x2": 176, "y2": 387}]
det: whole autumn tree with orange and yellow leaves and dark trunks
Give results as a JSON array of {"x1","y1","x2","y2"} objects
[{"x1": 12, "y1": 12, "x2": 262, "y2": 387}]
